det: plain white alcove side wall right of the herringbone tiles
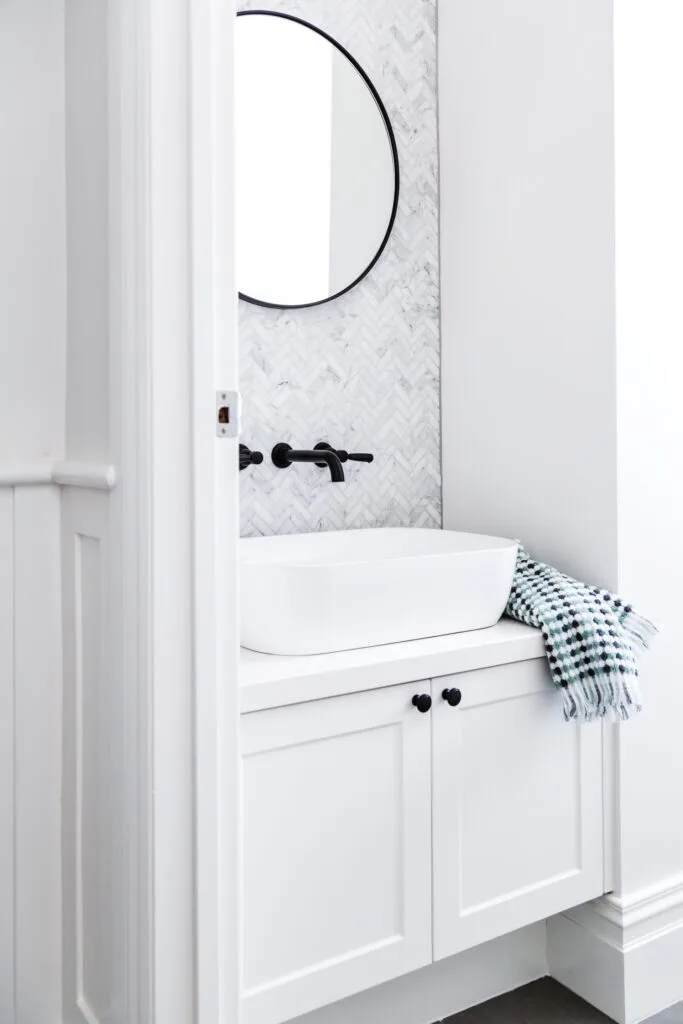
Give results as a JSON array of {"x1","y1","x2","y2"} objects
[{"x1": 439, "y1": 0, "x2": 616, "y2": 586}]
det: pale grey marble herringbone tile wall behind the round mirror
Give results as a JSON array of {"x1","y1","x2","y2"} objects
[{"x1": 240, "y1": 0, "x2": 441, "y2": 537}]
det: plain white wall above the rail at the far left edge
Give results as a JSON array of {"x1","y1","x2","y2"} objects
[{"x1": 0, "y1": 0, "x2": 66, "y2": 463}]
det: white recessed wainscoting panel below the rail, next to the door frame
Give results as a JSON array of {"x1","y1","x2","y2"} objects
[{"x1": 62, "y1": 488, "x2": 126, "y2": 1024}]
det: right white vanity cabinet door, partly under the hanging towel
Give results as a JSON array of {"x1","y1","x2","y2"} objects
[{"x1": 432, "y1": 659, "x2": 603, "y2": 959}]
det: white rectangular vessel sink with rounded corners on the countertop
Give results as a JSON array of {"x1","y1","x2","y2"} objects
[{"x1": 241, "y1": 528, "x2": 517, "y2": 654}]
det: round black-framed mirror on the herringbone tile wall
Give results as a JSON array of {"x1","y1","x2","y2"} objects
[{"x1": 236, "y1": 11, "x2": 398, "y2": 308}]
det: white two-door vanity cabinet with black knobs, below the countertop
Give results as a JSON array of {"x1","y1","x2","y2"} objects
[{"x1": 242, "y1": 641, "x2": 603, "y2": 1024}]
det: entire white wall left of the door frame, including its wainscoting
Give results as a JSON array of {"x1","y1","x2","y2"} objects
[{"x1": 0, "y1": 0, "x2": 143, "y2": 1024}]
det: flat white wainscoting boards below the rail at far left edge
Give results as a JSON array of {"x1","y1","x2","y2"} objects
[{"x1": 0, "y1": 485, "x2": 61, "y2": 1024}]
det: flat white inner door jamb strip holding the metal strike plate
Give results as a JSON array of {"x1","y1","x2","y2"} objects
[{"x1": 190, "y1": 0, "x2": 242, "y2": 1024}]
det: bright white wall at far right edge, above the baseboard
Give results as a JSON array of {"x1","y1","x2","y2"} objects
[{"x1": 614, "y1": 0, "x2": 683, "y2": 897}]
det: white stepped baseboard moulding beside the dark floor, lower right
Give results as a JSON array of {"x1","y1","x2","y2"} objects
[{"x1": 548, "y1": 876, "x2": 683, "y2": 1024}]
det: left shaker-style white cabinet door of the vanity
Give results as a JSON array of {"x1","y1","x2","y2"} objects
[{"x1": 242, "y1": 683, "x2": 431, "y2": 1024}]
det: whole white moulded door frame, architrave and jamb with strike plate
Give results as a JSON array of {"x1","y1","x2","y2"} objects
[{"x1": 117, "y1": 0, "x2": 241, "y2": 1024}]
